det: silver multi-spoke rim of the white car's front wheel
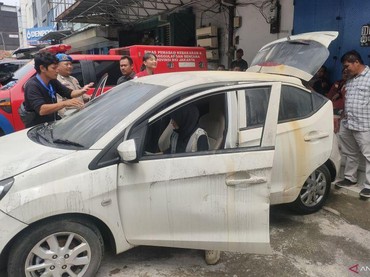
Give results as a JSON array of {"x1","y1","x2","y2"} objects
[{"x1": 25, "y1": 232, "x2": 91, "y2": 277}]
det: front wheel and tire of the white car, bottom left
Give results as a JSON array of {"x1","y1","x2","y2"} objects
[{"x1": 8, "y1": 220, "x2": 104, "y2": 277}]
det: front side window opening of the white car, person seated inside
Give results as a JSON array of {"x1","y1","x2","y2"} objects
[{"x1": 143, "y1": 93, "x2": 227, "y2": 158}]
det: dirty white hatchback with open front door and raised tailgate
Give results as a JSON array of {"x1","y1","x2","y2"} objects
[{"x1": 0, "y1": 32, "x2": 339, "y2": 277}]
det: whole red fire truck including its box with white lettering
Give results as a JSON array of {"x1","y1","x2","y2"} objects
[{"x1": 0, "y1": 44, "x2": 207, "y2": 136}]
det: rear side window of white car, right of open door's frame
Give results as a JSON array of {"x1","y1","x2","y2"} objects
[{"x1": 278, "y1": 86, "x2": 313, "y2": 123}]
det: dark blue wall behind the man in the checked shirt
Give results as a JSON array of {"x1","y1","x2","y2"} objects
[{"x1": 294, "y1": 0, "x2": 370, "y2": 81}]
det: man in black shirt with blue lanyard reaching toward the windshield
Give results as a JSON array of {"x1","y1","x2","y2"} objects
[{"x1": 19, "y1": 52, "x2": 92, "y2": 128}]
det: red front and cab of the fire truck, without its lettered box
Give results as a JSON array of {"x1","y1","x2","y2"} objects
[{"x1": 0, "y1": 44, "x2": 121, "y2": 136}]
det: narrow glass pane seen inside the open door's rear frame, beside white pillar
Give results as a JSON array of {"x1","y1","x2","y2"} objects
[{"x1": 245, "y1": 87, "x2": 271, "y2": 128}]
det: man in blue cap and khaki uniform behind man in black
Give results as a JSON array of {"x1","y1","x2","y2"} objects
[{"x1": 55, "y1": 53, "x2": 90, "y2": 117}]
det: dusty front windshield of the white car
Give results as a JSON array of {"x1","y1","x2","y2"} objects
[{"x1": 30, "y1": 82, "x2": 165, "y2": 149}]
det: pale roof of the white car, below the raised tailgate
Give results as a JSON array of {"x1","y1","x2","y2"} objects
[{"x1": 134, "y1": 70, "x2": 302, "y2": 89}]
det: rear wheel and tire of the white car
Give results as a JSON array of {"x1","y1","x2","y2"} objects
[{"x1": 290, "y1": 165, "x2": 331, "y2": 214}]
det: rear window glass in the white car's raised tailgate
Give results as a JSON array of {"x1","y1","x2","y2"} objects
[{"x1": 251, "y1": 40, "x2": 329, "y2": 75}]
